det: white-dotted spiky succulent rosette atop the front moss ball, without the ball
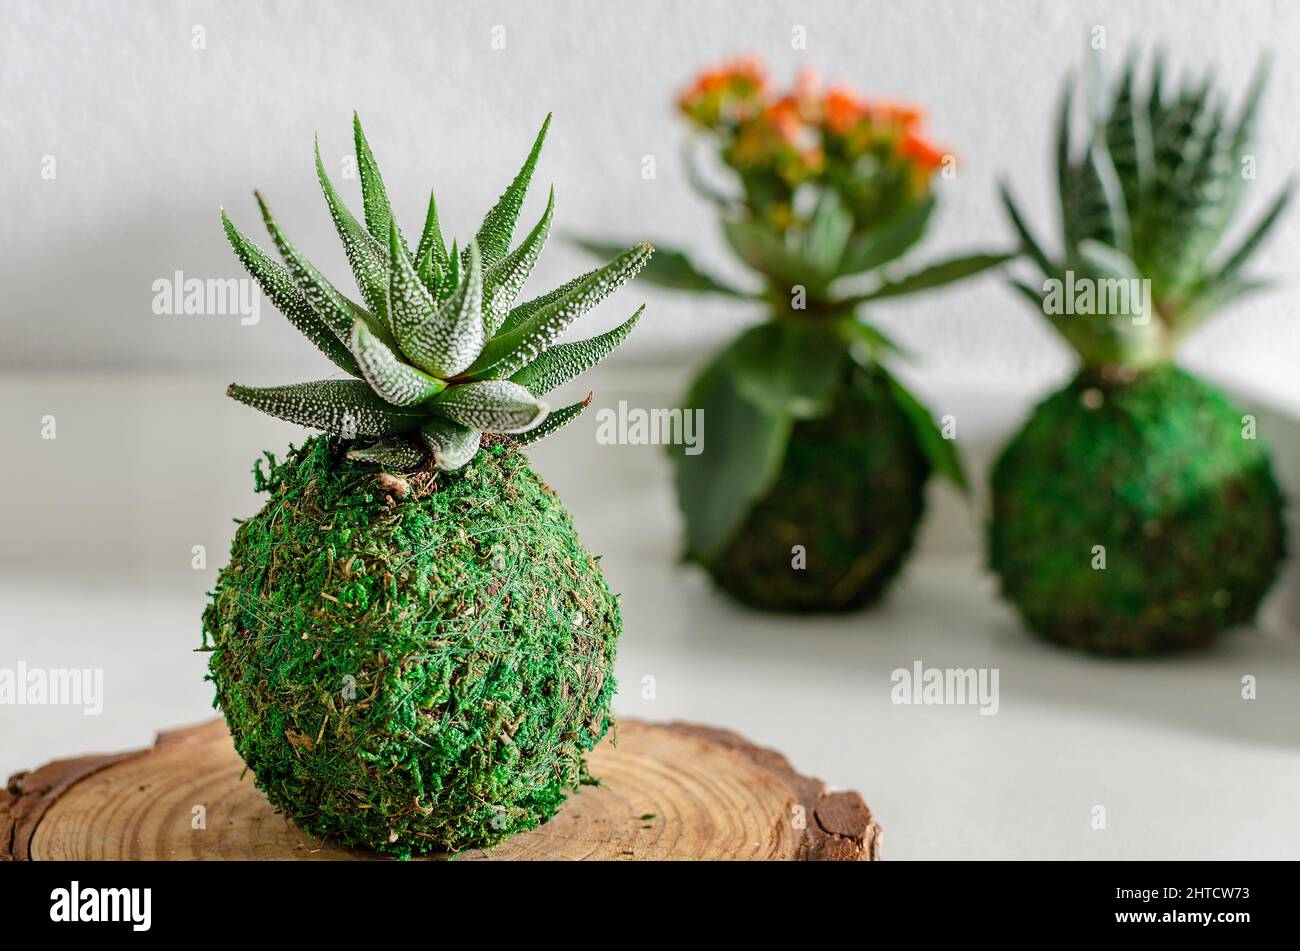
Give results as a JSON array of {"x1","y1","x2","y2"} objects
[{"x1": 221, "y1": 117, "x2": 651, "y2": 469}]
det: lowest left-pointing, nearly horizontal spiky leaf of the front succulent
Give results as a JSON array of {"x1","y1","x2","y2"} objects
[{"x1": 226, "y1": 379, "x2": 429, "y2": 439}]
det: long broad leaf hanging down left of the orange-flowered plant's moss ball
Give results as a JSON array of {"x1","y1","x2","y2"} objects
[{"x1": 668, "y1": 351, "x2": 792, "y2": 560}]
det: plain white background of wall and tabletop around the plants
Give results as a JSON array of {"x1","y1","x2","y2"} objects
[{"x1": 0, "y1": 0, "x2": 1300, "y2": 857}]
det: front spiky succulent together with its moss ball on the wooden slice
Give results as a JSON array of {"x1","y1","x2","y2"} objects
[{"x1": 203, "y1": 114, "x2": 650, "y2": 856}]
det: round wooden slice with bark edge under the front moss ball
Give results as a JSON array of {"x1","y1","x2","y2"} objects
[{"x1": 0, "y1": 720, "x2": 880, "y2": 861}]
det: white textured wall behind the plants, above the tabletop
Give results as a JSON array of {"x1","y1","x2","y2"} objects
[{"x1": 0, "y1": 0, "x2": 1300, "y2": 403}]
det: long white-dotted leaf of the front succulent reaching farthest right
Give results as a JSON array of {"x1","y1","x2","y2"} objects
[{"x1": 467, "y1": 244, "x2": 654, "y2": 379}]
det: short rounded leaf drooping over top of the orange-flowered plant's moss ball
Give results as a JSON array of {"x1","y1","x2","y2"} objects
[{"x1": 729, "y1": 320, "x2": 848, "y2": 420}]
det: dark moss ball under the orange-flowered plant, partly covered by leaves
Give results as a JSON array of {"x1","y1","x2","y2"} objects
[{"x1": 705, "y1": 365, "x2": 930, "y2": 612}]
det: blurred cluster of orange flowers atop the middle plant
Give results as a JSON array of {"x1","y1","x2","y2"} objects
[{"x1": 677, "y1": 57, "x2": 946, "y2": 195}]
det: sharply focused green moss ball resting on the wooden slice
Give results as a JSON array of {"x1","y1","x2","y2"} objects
[{"x1": 203, "y1": 437, "x2": 621, "y2": 856}]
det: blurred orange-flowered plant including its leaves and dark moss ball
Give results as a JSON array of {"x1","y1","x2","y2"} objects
[{"x1": 584, "y1": 60, "x2": 1008, "y2": 611}]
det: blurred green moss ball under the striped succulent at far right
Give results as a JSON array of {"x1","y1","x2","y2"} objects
[{"x1": 989, "y1": 366, "x2": 1284, "y2": 653}]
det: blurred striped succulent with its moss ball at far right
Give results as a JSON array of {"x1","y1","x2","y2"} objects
[{"x1": 989, "y1": 56, "x2": 1291, "y2": 653}]
